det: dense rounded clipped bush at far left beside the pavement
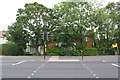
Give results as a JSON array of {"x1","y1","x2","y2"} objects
[{"x1": 2, "y1": 42, "x2": 19, "y2": 56}]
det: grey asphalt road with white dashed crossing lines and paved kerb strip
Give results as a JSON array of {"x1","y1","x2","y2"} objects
[{"x1": 0, "y1": 56, "x2": 120, "y2": 78}]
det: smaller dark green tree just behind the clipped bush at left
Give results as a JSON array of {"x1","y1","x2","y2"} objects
[{"x1": 6, "y1": 22, "x2": 29, "y2": 53}]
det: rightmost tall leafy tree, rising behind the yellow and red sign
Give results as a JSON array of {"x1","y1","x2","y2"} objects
[{"x1": 88, "y1": 3, "x2": 117, "y2": 53}]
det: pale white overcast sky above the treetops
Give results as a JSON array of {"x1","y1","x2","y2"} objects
[{"x1": 0, "y1": 0, "x2": 119, "y2": 31}]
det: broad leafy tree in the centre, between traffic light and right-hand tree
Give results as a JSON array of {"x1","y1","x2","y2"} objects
[{"x1": 54, "y1": 2, "x2": 91, "y2": 50}]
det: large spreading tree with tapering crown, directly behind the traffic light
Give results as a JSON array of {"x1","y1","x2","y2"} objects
[{"x1": 17, "y1": 2, "x2": 54, "y2": 55}]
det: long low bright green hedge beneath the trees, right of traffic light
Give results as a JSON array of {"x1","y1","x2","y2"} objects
[{"x1": 47, "y1": 47, "x2": 114, "y2": 56}]
